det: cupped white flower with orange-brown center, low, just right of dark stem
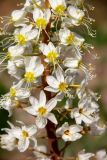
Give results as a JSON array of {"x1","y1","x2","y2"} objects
[{"x1": 56, "y1": 123, "x2": 83, "y2": 141}]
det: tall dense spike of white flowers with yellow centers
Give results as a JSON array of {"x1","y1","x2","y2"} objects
[{"x1": 0, "y1": 0, "x2": 106, "y2": 160}]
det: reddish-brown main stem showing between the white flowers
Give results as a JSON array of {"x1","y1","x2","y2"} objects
[{"x1": 42, "y1": 0, "x2": 60, "y2": 160}]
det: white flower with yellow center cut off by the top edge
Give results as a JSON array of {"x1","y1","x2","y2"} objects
[{"x1": 49, "y1": 0, "x2": 66, "y2": 15}]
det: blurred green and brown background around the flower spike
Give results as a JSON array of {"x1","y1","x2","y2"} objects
[{"x1": 0, "y1": 0, "x2": 107, "y2": 160}]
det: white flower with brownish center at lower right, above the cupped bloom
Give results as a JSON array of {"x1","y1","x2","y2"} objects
[{"x1": 71, "y1": 97, "x2": 97, "y2": 125}]
